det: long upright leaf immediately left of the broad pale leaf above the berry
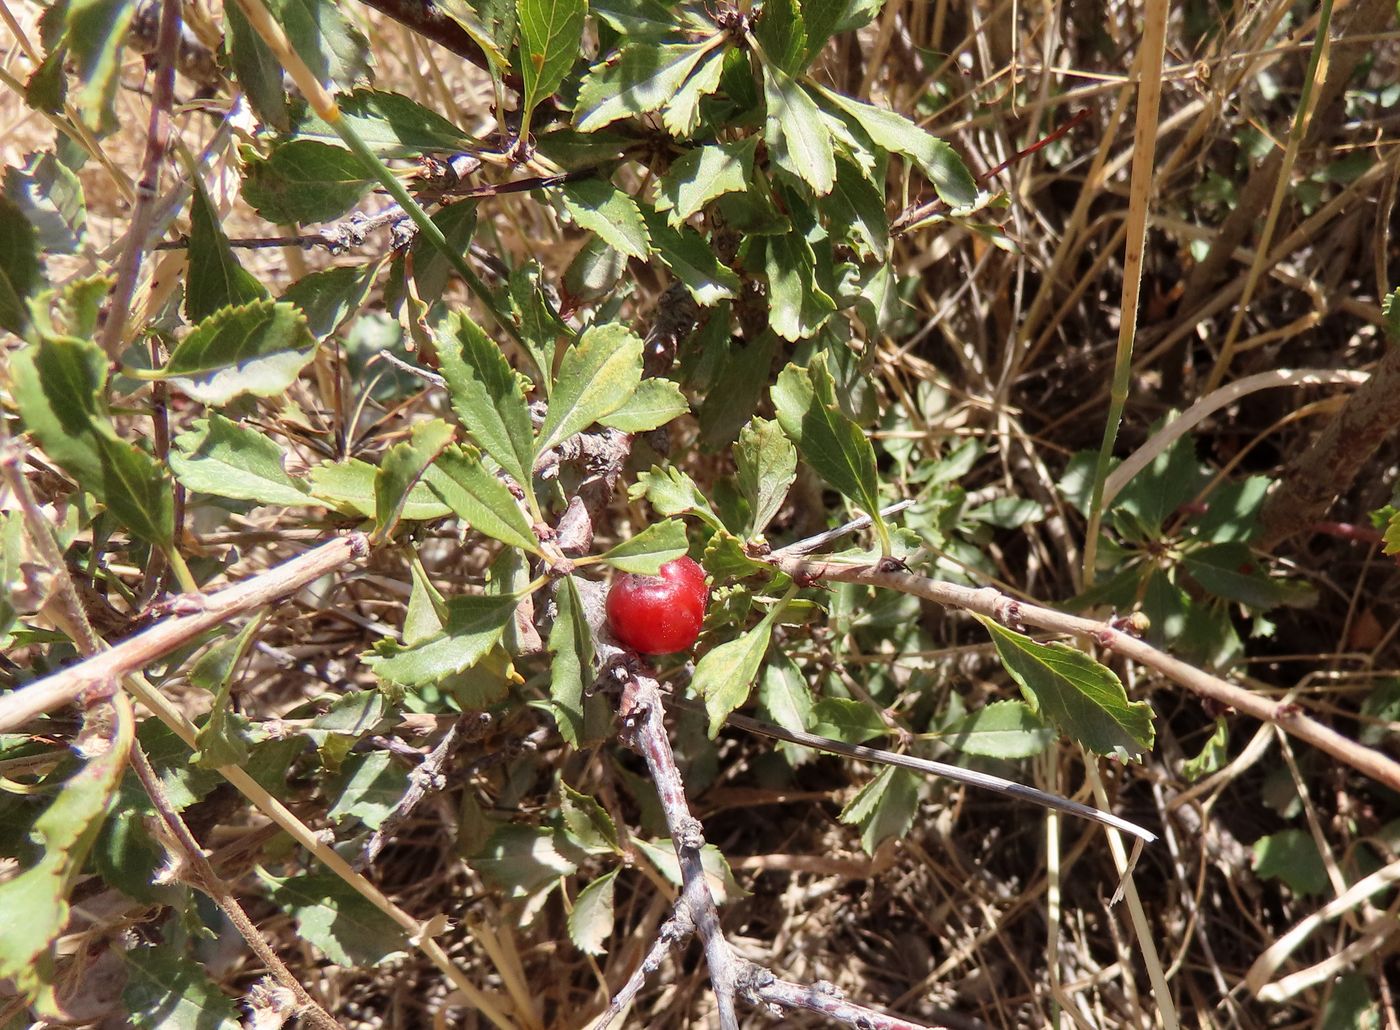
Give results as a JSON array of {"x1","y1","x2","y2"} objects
[{"x1": 437, "y1": 311, "x2": 535, "y2": 490}]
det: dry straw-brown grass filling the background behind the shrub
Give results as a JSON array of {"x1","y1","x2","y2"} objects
[{"x1": 0, "y1": 0, "x2": 1400, "y2": 1030}]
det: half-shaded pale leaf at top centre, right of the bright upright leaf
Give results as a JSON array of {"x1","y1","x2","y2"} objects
[{"x1": 574, "y1": 39, "x2": 718, "y2": 133}]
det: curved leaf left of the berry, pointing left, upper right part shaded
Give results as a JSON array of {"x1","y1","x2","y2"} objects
[{"x1": 361, "y1": 596, "x2": 518, "y2": 690}]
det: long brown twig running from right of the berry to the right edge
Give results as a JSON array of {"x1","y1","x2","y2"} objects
[{"x1": 773, "y1": 558, "x2": 1400, "y2": 791}]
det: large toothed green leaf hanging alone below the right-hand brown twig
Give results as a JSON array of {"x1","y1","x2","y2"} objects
[{"x1": 977, "y1": 616, "x2": 1154, "y2": 760}]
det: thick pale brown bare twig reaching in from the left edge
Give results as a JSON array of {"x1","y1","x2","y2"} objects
[{"x1": 0, "y1": 533, "x2": 368, "y2": 733}]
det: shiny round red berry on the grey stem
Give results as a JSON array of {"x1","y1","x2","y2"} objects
[{"x1": 608, "y1": 558, "x2": 710, "y2": 655}]
